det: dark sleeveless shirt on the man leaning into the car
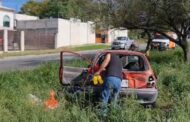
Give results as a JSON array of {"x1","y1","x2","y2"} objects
[{"x1": 105, "y1": 54, "x2": 122, "y2": 79}]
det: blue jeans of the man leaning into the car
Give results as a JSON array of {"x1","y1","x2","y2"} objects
[{"x1": 101, "y1": 76, "x2": 121, "y2": 105}]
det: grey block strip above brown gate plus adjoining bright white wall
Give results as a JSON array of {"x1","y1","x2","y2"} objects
[{"x1": 17, "y1": 19, "x2": 95, "y2": 48}]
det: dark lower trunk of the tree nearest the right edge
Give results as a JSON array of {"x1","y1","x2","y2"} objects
[{"x1": 181, "y1": 39, "x2": 190, "y2": 62}]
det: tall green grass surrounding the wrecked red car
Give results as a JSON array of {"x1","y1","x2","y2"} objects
[{"x1": 0, "y1": 49, "x2": 190, "y2": 122}]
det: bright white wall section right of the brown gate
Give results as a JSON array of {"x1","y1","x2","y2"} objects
[{"x1": 55, "y1": 19, "x2": 95, "y2": 48}]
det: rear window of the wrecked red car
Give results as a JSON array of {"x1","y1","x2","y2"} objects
[{"x1": 121, "y1": 56, "x2": 145, "y2": 71}]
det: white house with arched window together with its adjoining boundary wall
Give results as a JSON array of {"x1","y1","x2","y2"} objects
[{"x1": 0, "y1": 4, "x2": 95, "y2": 52}]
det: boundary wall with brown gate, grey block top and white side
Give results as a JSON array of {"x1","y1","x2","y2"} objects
[{"x1": 16, "y1": 18, "x2": 95, "y2": 50}]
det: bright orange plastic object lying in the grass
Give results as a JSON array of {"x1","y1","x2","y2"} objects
[{"x1": 44, "y1": 90, "x2": 58, "y2": 109}]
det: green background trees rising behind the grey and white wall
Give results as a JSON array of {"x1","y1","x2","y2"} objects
[{"x1": 20, "y1": 0, "x2": 110, "y2": 28}]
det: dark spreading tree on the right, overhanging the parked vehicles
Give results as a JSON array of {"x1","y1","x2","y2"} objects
[{"x1": 107, "y1": 0, "x2": 190, "y2": 61}]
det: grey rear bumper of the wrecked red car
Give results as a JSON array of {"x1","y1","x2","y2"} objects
[{"x1": 120, "y1": 88, "x2": 158, "y2": 104}]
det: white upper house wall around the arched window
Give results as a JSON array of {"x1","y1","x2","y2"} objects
[{"x1": 0, "y1": 9, "x2": 14, "y2": 30}]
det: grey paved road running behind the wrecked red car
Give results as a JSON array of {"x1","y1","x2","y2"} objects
[{"x1": 0, "y1": 45, "x2": 145, "y2": 72}]
